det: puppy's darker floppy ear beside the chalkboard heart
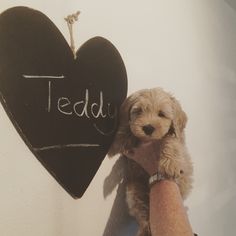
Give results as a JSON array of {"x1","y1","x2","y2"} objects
[{"x1": 108, "y1": 92, "x2": 139, "y2": 157}]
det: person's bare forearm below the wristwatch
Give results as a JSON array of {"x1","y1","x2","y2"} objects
[{"x1": 150, "y1": 180, "x2": 193, "y2": 236}]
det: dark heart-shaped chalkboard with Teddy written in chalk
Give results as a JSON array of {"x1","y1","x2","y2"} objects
[{"x1": 0, "y1": 7, "x2": 127, "y2": 198}]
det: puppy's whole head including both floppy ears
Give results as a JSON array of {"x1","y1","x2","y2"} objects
[{"x1": 109, "y1": 88, "x2": 187, "y2": 156}]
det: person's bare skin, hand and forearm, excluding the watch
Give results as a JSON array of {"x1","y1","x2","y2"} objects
[{"x1": 126, "y1": 142, "x2": 193, "y2": 236}]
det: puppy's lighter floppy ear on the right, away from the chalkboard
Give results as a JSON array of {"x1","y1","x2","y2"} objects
[{"x1": 171, "y1": 97, "x2": 188, "y2": 138}]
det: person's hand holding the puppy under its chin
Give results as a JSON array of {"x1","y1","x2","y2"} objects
[{"x1": 124, "y1": 141, "x2": 160, "y2": 176}]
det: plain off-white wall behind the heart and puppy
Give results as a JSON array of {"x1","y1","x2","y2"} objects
[{"x1": 0, "y1": 0, "x2": 236, "y2": 236}]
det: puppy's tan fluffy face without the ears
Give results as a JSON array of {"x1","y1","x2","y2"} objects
[{"x1": 124, "y1": 88, "x2": 183, "y2": 141}]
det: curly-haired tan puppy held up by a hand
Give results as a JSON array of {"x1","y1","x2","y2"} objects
[{"x1": 104, "y1": 88, "x2": 193, "y2": 236}]
